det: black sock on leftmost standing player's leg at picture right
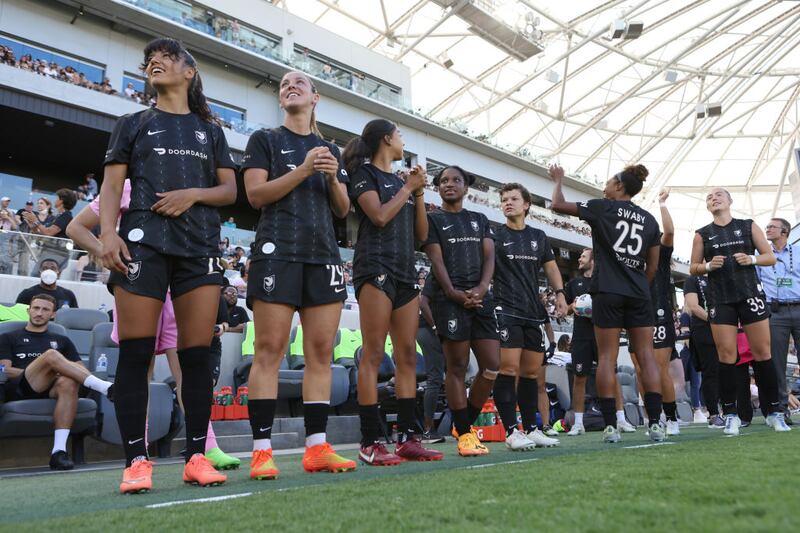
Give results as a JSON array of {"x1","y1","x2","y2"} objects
[{"x1": 178, "y1": 346, "x2": 214, "y2": 462}]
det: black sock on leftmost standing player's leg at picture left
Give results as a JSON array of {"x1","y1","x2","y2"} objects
[{"x1": 114, "y1": 337, "x2": 156, "y2": 466}]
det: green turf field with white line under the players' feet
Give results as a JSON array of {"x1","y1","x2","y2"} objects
[{"x1": 0, "y1": 419, "x2": 800, "y2": 533}]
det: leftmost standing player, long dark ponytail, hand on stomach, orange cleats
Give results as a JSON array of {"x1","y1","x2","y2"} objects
[{"x1": 100, "y1": 39, "x2": 236, "y2": 493}]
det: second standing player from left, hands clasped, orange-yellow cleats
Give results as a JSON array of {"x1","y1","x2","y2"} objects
[{"x1": 242, "y1": 72, "x2": 356, "y2": 479}]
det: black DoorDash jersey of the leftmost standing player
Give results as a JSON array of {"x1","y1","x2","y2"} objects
[{"x1": 105, "y1": 108, "x2": 236, "y2": 257}]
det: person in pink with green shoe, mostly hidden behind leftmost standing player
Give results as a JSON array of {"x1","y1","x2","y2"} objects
[{"x1": 67, "y1": 179, "x2": 241, "y2": 470}]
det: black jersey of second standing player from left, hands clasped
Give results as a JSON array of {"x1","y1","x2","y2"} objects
[{"x1": 242, "y1": 126, "x2": 349, "y2": 265}]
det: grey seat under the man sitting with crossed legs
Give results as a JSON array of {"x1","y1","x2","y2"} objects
[{"x1": 0, "y1": 321, "x2": 97, "y2": 464}]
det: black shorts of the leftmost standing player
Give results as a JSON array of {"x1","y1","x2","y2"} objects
[{"x1": 108, "y1": 243, "x2": 224, "y2": 302}]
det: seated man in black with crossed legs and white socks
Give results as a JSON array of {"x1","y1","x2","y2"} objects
[{"x1": 0, "y1": 294, "x2": 113, "y2": 470}]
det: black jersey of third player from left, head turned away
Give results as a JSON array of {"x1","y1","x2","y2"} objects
[{"x1": 350, "y1": 165, "x2": 417, "y2": 284}]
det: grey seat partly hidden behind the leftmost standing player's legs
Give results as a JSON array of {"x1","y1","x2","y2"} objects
[{"x1": 89, "y1": 322, "x2": 177, "y2": 454}]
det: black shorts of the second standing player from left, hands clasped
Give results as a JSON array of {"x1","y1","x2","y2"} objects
[{"x1": 247, "y1": 259, "x2": 347, "y2": 309}]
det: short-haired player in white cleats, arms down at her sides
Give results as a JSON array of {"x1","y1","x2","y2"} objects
[{"x1": 494, "y1": 183, "x2": 567, "y2": 451}]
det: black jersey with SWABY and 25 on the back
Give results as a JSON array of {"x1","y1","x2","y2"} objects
[{"x1": 578, "y1": 199, "x2": 659, "y2": 300}]
